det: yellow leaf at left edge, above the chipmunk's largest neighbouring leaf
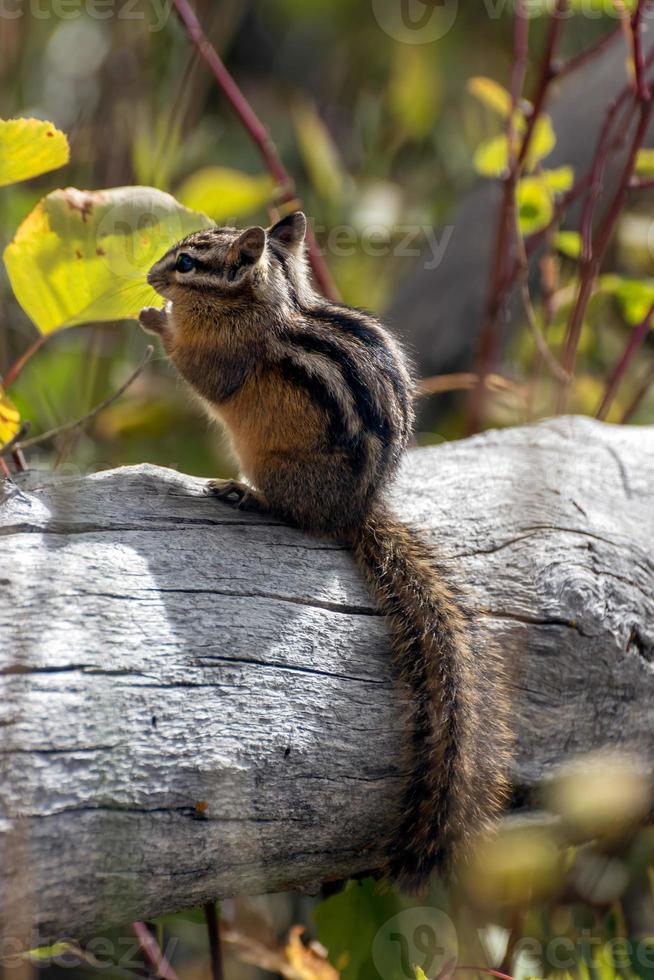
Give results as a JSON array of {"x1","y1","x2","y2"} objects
[{"x1": 0, "y1": 119, "x2": 70, "y2": 187}]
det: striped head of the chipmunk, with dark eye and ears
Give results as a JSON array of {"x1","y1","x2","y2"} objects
[{"x1": 148, "y1": 211, "x2": 307, "y2": 302}]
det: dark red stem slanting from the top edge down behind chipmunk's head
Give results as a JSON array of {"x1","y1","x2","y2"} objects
[{"x1": 173, "y1": 0, "x2": 339, "y2": 302}]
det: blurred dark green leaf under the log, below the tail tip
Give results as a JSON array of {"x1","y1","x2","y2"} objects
[{"x1": 314, "y1": 878, "x2": 404, "y2": 980}]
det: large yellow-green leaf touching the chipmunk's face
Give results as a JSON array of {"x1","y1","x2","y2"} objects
[{"x1": 4, "y1": 187, "x2": 212, "y2": 333}]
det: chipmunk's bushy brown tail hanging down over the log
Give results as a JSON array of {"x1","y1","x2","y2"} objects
[{"x1": 351, "y1": 506, "x2": 510, "y2": 889}]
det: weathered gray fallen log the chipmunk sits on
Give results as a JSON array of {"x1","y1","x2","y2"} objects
[{"x1": 0, "y1": 419, "x2": 654, "y2": 944}]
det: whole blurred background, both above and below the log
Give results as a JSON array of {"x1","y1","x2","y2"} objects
[{"x1": 0, "y1": 0, "x2": 654, "y2": 980}]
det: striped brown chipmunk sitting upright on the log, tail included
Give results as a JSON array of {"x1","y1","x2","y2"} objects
[{"x1": 139, "y1": 211, "x2": 509, "y2": 890}]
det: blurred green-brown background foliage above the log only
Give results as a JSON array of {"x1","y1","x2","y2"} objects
[{"x1": 0, "y1": 0, "x2": 654, "y2": 475}]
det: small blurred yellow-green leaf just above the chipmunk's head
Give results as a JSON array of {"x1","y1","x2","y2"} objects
[{"x1": 177, "y1": 167, "x2": 275, "y2": 223}]
